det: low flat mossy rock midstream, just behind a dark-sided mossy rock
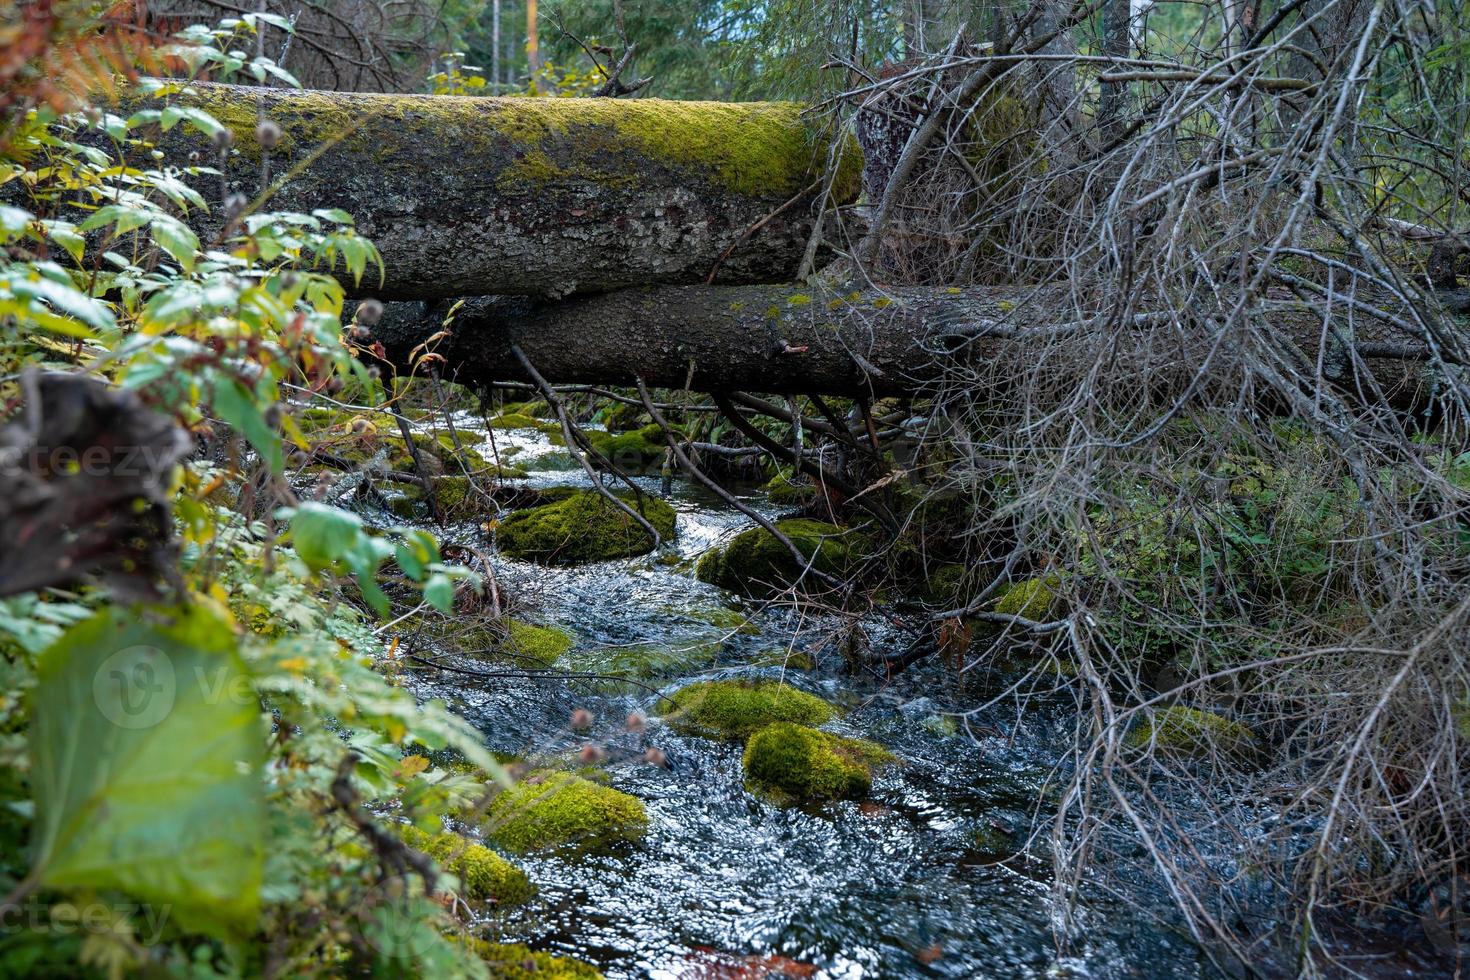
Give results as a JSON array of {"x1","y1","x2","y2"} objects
[{"x1": 660, "y1": 680, "x2": 835, "y2": 742}]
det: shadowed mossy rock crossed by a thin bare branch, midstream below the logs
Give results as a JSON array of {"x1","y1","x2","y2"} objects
[{"x1": 694, "y1": 517, "x2": 870, "y2": 597}]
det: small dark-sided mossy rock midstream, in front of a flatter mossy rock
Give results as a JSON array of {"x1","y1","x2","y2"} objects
[{"x1": 741, "y1": 721, "x2": 894, "y2": 802}]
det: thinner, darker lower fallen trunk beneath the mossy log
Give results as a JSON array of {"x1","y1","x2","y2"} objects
[{"x1": 375, "y1": 285, "x2": 1427, "y2": 404}]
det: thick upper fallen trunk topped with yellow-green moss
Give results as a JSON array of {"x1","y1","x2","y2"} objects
[{"x1": 125, "y1": 85, "x2": 860, "y2": 300}]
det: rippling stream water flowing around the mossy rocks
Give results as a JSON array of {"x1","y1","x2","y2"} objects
[{"x1": 391, "y1": 432, "x2": 1208, "y2": 979}]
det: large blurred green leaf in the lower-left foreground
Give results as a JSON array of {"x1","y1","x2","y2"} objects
[{"x1": 31, "y1": 608, "x2": 266, "y2": 937}]
